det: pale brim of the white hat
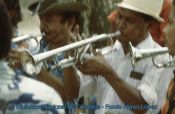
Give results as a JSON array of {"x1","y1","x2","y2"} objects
[{"x1": 117, "y1": 3, "x2": 164, "y2": 22}]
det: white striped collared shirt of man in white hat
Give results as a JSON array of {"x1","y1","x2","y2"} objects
[{"x1": 78, "y1": 35, "x2": 175, "y2": 114}]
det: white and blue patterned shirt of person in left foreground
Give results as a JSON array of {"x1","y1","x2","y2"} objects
[{"x1": 0, "y1": 61, "x2": 65, "y2": 114}]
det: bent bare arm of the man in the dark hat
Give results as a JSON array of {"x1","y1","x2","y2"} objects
[{"x1": 38, "y1": 67, "x2": 79, "y2": 102}]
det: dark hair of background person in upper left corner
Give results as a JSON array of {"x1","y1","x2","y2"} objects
[{"x1": 4, "y1": 0, "x2": 22, "y2": 26}]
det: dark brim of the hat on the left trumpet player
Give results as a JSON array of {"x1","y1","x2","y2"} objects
[{"x1": 28, "y1": 2, "x2": 88, "y2": 15}]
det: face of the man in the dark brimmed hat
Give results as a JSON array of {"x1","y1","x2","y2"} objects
[{"x1": 40, "y1": 14, "x2": 71, "y2": 48}]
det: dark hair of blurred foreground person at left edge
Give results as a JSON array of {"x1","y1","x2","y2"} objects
[{"x1": 0, "y1": 0, "x2": 12, "y2": 59}]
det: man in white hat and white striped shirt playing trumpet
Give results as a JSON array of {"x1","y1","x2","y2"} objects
[{"x1": 67, "y1": 0, "x2": 172, "y2": 114}]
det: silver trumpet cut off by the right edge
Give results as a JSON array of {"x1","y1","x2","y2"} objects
[{"x1": 129, "y1": 42, "x2": 175, "y2": 68}]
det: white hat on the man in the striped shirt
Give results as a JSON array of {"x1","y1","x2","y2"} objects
[{"x1": 117, "y1": 0, "x2": 164, "y2": 22}]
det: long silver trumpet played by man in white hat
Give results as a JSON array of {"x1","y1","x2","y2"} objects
[{"x1": 21, "y1": 31, "x2": 120, "y2": 75}]
